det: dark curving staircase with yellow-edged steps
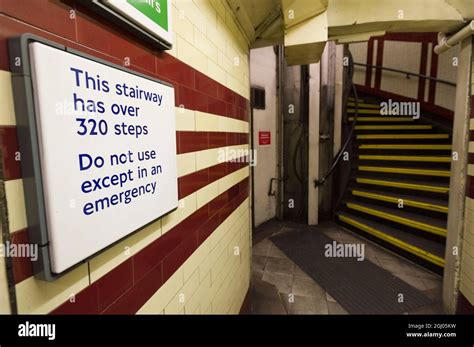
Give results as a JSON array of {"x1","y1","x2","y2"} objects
[{"x1": 336, "y1": 95, "x2": 451, "y2": 274}]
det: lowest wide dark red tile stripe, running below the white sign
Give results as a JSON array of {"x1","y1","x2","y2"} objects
[{"x1": 51, "y1": 178, "x2": 249, "y2": 314}]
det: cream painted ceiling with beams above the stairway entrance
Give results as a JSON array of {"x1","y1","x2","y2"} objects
[{"x1": 227, "y1": 0, "x2": 474, "y2": 64}]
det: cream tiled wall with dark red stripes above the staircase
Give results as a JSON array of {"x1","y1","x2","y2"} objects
[{"x1": 349, "y1": 33, "x2": 458, "y2": 119}]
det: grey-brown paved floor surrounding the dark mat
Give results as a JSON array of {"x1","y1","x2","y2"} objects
[{"x1": 251, "y1": 221, "x2": 443, "y2": 314}]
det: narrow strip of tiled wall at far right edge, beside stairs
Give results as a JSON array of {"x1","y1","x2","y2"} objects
[{"x1": 458, "y1": 40, "x2": 474, "y2": 313}]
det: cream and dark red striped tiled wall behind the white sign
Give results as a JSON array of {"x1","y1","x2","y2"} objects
[{"x1": 0, "y1": 0, "x2": 250, "y2": 314}]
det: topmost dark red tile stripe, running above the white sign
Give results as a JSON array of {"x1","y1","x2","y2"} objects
[{"x1": 0, "y1": 1, "x2": 249, "y2": 121}]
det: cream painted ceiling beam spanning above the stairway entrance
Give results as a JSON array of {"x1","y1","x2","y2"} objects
[{"x1": 281, "y1": 0, "x2": 464, "y2": 65}]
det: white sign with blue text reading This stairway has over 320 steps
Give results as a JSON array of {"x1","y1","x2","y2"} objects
[{"x1": 29, "y1": 42, "x2": 178, "y2": 273}]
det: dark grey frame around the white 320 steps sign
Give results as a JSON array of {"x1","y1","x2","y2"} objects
[{"x1": 8, "y1": 33, "x2": 179, "y2": 282}]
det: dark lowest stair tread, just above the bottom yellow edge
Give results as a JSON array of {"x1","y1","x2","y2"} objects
[{"x1": 337, "y1": 211, "x2": 445, "y2": 258}]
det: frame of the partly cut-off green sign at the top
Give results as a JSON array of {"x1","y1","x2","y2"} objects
[{"x1": 77, "y1": 0, "x2": 174, "y2": 50}]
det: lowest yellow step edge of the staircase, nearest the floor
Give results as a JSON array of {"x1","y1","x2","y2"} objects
[{"x1": 338, "y1": 215, "x2": 445, "y2": 267}]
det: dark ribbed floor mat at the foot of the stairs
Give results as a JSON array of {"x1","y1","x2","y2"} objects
[{"x1": 270, "y1": 231, "x2": 433, "y2": 314}]
